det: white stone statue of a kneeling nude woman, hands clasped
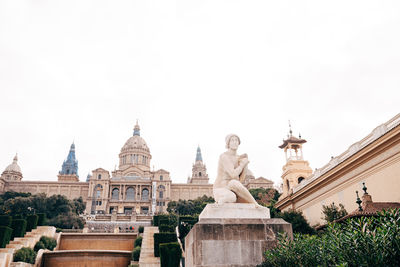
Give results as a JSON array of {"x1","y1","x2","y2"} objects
[{"x1": 213, "y1": 134, "x2": 262, "y2": 207}]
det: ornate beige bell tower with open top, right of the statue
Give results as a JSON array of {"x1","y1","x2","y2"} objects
[{"x1": 279, "y1": 124, "x2": 312, "y2": 198}]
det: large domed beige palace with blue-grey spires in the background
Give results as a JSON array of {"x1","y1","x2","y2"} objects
[{"x1": 0, "y1": 123, "x2": 273, "y2": 217}]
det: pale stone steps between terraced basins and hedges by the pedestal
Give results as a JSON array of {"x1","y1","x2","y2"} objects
[{"x1": 139, "y1": 226, "x2": 160, "y2": 267}]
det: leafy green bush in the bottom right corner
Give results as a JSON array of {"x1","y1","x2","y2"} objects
[{"x1": 259, "y1": 209, "x2": 400, "y2": 267}]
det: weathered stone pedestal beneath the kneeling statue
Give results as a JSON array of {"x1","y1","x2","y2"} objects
[{"x1": 185, "y1": 203, "x2": 292, "y2": 267}]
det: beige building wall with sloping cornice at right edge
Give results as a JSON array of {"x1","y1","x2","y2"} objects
[{"x1": 277, "y1": 114, "x2": 400, "y2": 225}]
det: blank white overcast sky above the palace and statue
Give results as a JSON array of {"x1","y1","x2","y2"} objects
[{"x1": 0, "y1": 0, "x2": 400, "y2": 186}]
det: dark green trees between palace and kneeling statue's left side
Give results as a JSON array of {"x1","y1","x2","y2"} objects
[{"x1": 167, "y1": 195, "x2": 215, "y2": 215}]
